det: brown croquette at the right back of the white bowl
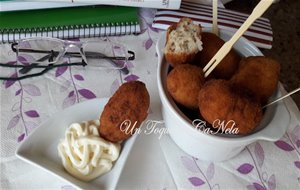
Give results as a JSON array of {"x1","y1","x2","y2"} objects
[{"x1": 230, "y1": 56, "x2": 280, "y2": 104}]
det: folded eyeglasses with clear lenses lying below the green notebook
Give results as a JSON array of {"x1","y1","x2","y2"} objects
[{"x1": 0, "y1": 37, "x2": 135, "y2": 80}]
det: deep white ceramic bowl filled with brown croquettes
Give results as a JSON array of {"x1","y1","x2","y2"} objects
[{"x1": 156, "y1": 30, "x2": 290, "y2": 161}]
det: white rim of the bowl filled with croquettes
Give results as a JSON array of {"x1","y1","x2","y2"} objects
[{"x1": 156, "y1": 28, "x2": 291, "y2": 143}]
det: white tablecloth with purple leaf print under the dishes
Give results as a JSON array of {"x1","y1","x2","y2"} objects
[{"x1": 0, "y1": 9, "x2": 300, "y2": 190}]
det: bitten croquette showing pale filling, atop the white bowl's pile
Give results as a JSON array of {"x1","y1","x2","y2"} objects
[{"x1": 164, "y1": 18, "x2": 202, "y2": 67}]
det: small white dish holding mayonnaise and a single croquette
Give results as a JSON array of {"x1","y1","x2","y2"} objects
[{"x1": 16, "y1": 98, "x2": 137, "y2": 189}]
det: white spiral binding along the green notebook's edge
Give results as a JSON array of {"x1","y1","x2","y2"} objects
[{"x1": 0, "y1": 22, "x2": 140, "y2": 43}]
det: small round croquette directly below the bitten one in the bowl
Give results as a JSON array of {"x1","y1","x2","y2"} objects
[{"x1": 167, "y1": 64, "x2": 205, "y2": 109}]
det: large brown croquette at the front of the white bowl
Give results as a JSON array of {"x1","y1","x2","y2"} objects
[{"x1": 198, "y1": 80, "x2": 262, "y2": 135}]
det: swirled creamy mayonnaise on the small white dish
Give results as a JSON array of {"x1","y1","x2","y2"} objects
[{"x1": 58, "y1": 120, "x2": 120, "y2": 181}]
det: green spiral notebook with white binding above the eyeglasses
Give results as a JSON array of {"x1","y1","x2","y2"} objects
[{"x1": 0, "y1": 6, "x2": 141, "y2": 43}]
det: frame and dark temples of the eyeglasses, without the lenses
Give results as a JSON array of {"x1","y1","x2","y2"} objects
[{"x1": 0, "y1": 37, "x2": 135, "y2": 81}]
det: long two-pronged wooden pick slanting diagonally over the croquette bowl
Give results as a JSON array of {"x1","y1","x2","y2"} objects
[{"x1": 203, "y1": 0, "x2": 274, "y2": 77}]
